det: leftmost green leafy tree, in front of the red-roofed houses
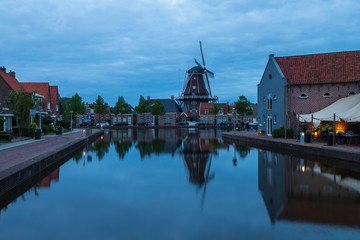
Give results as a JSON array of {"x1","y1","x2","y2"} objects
[{"x1": 5, "y1": 87, "x2": 39, "y2": 136}]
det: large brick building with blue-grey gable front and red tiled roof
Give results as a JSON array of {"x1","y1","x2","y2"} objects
[{"x1": 258, "y1": 51, "x2": 360, "y2": 135}]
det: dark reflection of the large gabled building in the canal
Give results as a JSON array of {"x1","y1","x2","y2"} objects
[{"x1": 258, "y1": 150, "x2": 360, "y2": 227}]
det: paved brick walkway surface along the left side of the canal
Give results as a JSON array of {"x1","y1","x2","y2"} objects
[{"x1": 0, "y1": 129, "x2": 93, "y2": 172}]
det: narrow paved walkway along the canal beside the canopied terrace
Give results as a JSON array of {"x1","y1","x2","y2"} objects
[{"x1": 224, "y1": 131, "x2": 360, "y2": 155}]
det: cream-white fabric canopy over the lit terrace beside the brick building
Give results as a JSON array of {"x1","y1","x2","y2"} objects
[{"x1": 297, "y1": 94, "x2": 360, "y2": 127}]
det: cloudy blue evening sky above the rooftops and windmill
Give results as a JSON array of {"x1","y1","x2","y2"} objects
[{"x1": 0, "y1": 0, "x2": 360, "y2": 106}]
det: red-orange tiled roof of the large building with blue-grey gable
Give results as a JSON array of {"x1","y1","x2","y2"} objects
[{"x1": 275, "y1": 51, "x2": 360, "y2": 84}]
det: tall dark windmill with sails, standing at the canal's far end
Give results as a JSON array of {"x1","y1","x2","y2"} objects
[{"x1": 178, "y1": 41, "x2": 214, "y2": 121}]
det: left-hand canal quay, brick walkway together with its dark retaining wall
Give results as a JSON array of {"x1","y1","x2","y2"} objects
[{"x1": 0, "y1": 129, "x2": 104, "y2": 196}]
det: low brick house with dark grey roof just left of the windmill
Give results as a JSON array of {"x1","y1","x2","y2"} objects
[{"x1": 137, "y1": 97, "x2": 182, "y2": 126}]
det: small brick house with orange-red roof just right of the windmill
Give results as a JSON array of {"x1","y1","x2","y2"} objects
[{"x1": 199, "y1": 102, "x2": 231, "y2": 124}]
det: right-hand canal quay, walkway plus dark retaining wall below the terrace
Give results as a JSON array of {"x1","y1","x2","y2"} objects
[{"x1": 222, "y1": 131, "x2": 360, "y2": 163}]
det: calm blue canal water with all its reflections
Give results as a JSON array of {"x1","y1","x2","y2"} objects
[{"x1": 0, "y1": 129, "x2": 360, "y2": 240}]
